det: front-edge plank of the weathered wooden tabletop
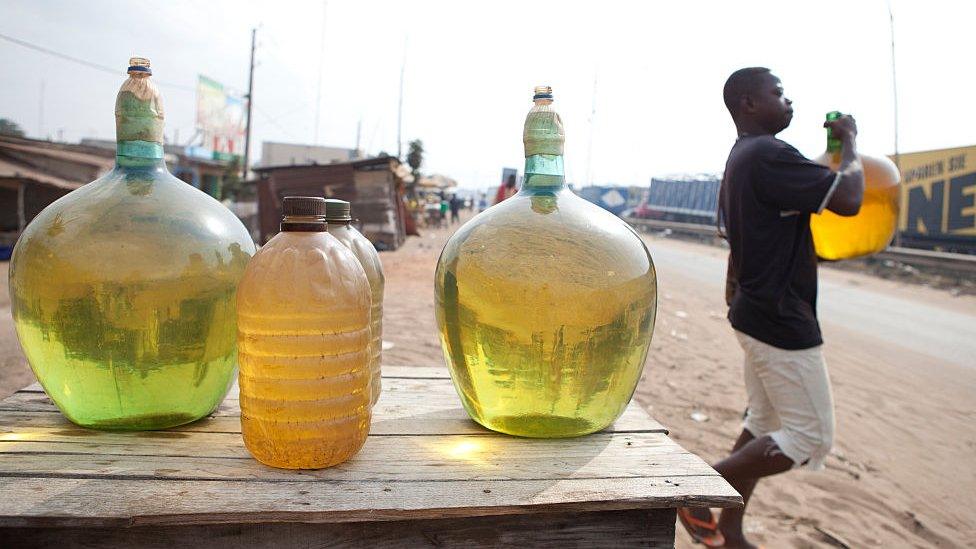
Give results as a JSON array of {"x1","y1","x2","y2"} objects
[{"x1": 0, "y1": 475, "x2": 742, "y2": 527}]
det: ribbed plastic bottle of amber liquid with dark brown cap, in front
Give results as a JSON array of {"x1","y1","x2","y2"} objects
[{"x1": 237, "y1": 197, "x2": 371, "y2": 469}]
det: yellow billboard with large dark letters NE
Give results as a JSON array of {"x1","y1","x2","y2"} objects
[{"x1": 891, "y1": 145, "x2": 976, "y2": 248}]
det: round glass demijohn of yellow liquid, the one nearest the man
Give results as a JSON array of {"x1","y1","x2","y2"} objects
[{"x1": 435, "y1": 87, "x2": 657, "y2": 438}]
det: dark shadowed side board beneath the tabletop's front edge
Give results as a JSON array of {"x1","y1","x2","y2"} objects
[{"x1": 0, "y1": 509, "x2": 675, "y2": 549}]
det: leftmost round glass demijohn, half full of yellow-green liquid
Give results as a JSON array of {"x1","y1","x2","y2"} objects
[{"x1": 10, "y1": 58, "x2": 254, "y2": 430}]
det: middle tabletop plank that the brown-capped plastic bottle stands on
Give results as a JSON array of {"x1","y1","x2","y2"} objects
[{"x1": 0, "y1": 431, "x2": 715, "y2": 482}]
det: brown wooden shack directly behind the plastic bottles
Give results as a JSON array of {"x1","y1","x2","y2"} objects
[{"x1": 254, "y1": 156, "x2": 406, "y2": 250}]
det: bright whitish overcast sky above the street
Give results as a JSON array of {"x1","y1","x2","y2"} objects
[{"x1": 0, "y1": 0, "x2": 976, "y2": 187}]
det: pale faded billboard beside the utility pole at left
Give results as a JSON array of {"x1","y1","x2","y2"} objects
[{"x1": 197, "y1": 75, "x2": 246, "y2": 157}]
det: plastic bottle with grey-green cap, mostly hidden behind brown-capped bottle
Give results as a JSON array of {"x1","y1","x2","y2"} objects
[{"x1": 325, "y1": 198, "x2": 385, "y2": 405}]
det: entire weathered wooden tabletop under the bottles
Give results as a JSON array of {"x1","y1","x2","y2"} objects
[{"x1": 0, "y1": 367, "x2": 741, "y2": 532}]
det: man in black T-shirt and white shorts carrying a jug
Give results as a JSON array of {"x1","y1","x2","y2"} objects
[{"x1": 678, "y1": 67, "x2": 864, "y2": 547}]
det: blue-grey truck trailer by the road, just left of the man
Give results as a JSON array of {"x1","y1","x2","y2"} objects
[{"x1": 622, "y1": 176, "x2": 722, "y2": 225}]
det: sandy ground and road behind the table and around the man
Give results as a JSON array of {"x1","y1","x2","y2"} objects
[{"x1": 0, "y1": 209, "x2": 976, "y2": 548}]
